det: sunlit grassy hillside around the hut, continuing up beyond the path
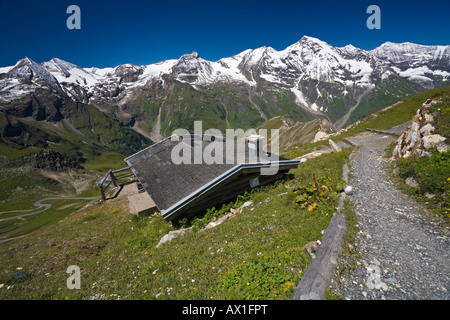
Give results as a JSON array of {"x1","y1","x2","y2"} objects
[{"x1": 0, "y1": 87, "x2": 449, "y2": 299}]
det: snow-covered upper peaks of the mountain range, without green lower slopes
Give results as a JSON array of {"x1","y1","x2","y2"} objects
[{"x1": 0, "y1": 35, "x2": 450, "y2": 120}]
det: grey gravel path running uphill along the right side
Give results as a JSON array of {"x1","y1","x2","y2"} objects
[{"x1": 336, "y1": 133, "x2": 450, "y2": 300}]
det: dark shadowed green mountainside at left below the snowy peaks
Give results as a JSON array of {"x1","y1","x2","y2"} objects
[{"x1": 0, "y1": 101, "x2": 153, "y2": 160}]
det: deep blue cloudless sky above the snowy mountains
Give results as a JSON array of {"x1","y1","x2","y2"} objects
[{"x1": 0, "y1": 0, "x2": 450, "y2": 67}]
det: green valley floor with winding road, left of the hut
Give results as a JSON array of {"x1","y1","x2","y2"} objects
[{"x1": 0, "y1": 151, "x2": 125, "y2": 240}]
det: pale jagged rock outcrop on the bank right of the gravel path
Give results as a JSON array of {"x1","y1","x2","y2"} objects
[{"x1": 392, "y1": 99, "x2": 450, "y2": 158}]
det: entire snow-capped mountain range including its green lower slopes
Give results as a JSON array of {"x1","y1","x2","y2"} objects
[{"x1": 0, "y1": 36, "x2": 450, "y2": 133}]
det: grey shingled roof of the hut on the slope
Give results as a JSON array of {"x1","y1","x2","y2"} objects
[{"x1": 125, "y1": 134, "x2": 299, "y2": 221}]
